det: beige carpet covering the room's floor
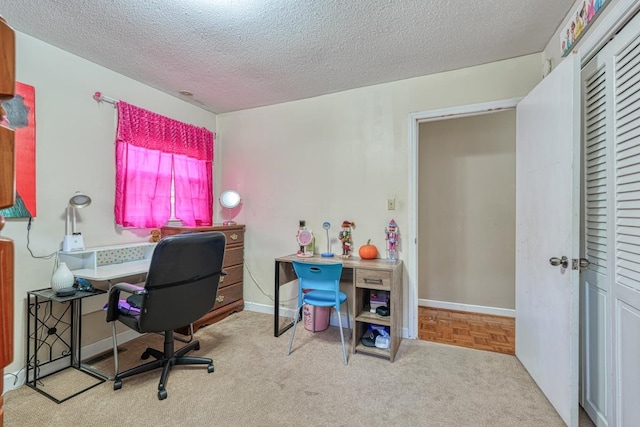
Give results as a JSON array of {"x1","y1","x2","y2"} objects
[{"x1": 5, "y1": 311, "x2": 564, "y2": 427}]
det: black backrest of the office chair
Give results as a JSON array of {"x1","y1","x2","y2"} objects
[{"x1": 140, "y1": 231, "x2": 226, "y2": 332}]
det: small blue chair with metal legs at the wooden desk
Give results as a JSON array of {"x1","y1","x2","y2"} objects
[{"x1": 287, "y1": 261, "x2": 351, "y2": 365}]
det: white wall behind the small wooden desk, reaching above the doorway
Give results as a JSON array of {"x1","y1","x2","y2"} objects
[{"x1": 218, "y1": 54, "x2": 542, "y2": 326}]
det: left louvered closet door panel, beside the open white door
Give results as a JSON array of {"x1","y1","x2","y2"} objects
[{"x1": 580, "y1": 52, "x2": 613, "y2": 425}]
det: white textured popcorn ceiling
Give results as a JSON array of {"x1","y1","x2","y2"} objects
[{"x1": 0, "y1": 0, "x2": 574, "y2": 113}]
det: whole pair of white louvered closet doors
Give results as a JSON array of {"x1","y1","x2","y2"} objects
[{"x1": 581, "y1": 15, "x2": 640, "y2": 426}]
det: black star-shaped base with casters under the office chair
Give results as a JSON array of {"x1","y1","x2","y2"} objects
[{"x1": 113, "y1": 323, "x2": 214, "y2": 400}]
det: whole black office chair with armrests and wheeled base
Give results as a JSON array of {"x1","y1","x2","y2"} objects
[{"x1": 107, "y1": 231, "x2": 225, "y2": 400}]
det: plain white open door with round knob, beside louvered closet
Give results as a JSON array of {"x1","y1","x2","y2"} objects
[{"x1": 516, "y1": 54, "x2": 580, "y2": 427}]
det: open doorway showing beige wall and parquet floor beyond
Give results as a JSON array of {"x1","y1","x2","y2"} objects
[{"x1": 418, "y1": 109, "x2": 516, "y2": 354}]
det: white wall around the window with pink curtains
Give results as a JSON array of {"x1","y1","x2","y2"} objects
[{"x1": 2, "y1": 33, "x2": 216, "y2": 373}]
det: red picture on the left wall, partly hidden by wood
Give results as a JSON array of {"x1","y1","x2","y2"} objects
[{"x1": 0, "y1": 82, "x2": 36, "y2": 218}]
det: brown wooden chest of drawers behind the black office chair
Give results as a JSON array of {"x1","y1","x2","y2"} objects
[{"x1": 161, "y1": 225, "x2": 244, "y2": 333}]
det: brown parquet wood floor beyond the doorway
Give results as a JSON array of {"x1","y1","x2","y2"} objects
[{"x1": 418, "y1": 307, "x2": 516, "y2": 355}]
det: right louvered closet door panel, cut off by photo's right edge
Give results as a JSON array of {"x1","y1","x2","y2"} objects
[{"x1": 610, "y1": 15, "x2": 640, "y2": 426}]
